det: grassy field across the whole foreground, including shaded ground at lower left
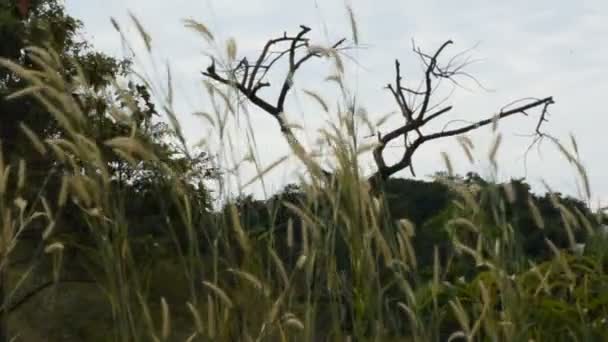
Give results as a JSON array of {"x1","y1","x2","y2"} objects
[{"x1": 0, "y1": 12, "x2": 608, "y2": 342}]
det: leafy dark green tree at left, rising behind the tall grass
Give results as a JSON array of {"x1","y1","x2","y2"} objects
[{"x1": 0, "y1": 0, "x2": 215, "y2": 341}]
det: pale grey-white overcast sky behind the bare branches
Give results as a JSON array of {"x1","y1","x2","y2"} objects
[{"x1": 65, "y1": 0, "x2": 608, "y2": 205}]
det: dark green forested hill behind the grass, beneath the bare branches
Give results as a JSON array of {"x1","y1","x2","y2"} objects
[{"x1": 224, "y1": 173, "x2": 608, "y2": 272}]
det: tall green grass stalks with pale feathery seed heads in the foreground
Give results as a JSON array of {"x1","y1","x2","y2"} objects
[{"x1": 0, "y1": 13, "x2": 608, "y2": 342}]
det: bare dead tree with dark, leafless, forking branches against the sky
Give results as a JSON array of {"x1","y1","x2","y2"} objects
[{"x1": 203, "y1": 26, "x2": 554, "y2": 188}]
